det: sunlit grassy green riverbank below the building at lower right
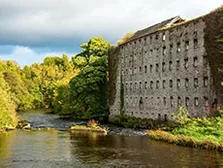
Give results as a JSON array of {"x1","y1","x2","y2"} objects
[{"x1": 148, "y1": 117, "x2": 223, "y2": 151}]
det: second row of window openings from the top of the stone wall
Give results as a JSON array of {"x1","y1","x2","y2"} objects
[{"x1": 122, "y1": 39, "x2": 198, "y2": 58}]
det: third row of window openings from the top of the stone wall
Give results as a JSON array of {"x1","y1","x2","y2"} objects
[{"x1": 126, "y1": 56, "x2": 207, "y2": 73}]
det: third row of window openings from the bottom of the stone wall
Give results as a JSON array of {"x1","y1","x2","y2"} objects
[{"x1": 126, "y1": 77, "x2": 208, "y2": 91}]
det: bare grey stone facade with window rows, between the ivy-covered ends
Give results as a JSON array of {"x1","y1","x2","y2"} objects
[{"x1": 110, "y1": 18, "x2": 216, "y2": 119}]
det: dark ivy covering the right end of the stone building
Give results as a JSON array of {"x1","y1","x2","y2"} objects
[{"x1": 204, "y1": 6, "x2": 223, "y2": 101}]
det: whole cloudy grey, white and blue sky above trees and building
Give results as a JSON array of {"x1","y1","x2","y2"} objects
[{"x1": 0, "y1": 0, "x2": 223, "y2": 66}]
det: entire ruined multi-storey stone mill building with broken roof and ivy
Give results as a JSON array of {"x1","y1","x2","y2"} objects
[{"x1": 109, "y1": 7, "x2": 223, "y2": 119}]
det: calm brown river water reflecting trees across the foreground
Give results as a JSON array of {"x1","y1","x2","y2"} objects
[{"x1": 0, "y1": 111, "x2": 223, "y2": 168}]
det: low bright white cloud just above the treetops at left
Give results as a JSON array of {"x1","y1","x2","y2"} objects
[{"x1": 0, "y1": 46, "x2": 74, "y2": 66}]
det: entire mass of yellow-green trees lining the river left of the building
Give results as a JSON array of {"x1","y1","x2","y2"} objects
[{"x1": 0, "y1": 37, "x2": 110, "y2": 128}]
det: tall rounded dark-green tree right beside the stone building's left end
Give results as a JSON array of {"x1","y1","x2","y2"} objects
[{"x1": 70, "y1": 37, "x2": 110, "y2": 119}]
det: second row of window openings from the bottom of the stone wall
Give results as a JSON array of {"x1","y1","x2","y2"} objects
[{"x1": 127, "y1": 96, "x2": 205, "y2": 107}]
